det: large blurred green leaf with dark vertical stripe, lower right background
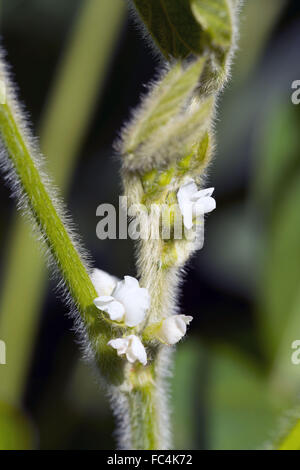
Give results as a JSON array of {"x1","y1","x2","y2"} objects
[{"x1": 172, "y1": 338, "x2": 286, "y2": 450}]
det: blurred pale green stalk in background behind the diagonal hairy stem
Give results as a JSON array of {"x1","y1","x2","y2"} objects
[{"x1": 0, "y1": 0, "x2": 125, "y2": 404}]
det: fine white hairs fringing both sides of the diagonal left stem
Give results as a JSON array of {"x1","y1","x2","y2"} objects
[{"x1": 0, "y1": 48, "x2": 103, "y2": 374}]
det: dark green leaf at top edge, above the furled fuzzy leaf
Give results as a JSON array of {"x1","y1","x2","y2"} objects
[{"x1": 134, "y1": 0, "x2": 232, "y2": 59}]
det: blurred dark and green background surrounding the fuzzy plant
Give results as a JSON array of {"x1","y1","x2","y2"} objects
[{"x1": 0, "y1": 0, "x2": 300, "y2": 449}]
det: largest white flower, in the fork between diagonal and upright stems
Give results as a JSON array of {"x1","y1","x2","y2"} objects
[{"x1": 94, "y1": 271, "x2": 150, "y2": 327}]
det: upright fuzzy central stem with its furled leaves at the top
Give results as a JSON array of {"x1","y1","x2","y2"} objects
[{"x1": 118, "y1": 0, "x2": 241, "y2": 449}]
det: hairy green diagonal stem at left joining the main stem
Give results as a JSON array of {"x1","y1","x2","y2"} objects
[{"x1": 0, "y1": 64, "x2": 122, "y2": 383}]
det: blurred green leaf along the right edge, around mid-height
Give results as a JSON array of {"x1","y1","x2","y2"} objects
[{"x1": 260, "y1": 174, "x2": 300, "y2": 380}]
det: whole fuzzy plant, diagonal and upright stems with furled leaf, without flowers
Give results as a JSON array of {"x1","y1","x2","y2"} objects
[{"x1": 0, "y1": 0, "x2": 241, "y2": 449}]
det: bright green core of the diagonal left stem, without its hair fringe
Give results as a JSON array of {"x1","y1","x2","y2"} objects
[{"x1": 0, "y1": 104, "x2": 97, "y2": 323}]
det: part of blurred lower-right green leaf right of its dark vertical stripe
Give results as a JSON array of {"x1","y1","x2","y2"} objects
[{"x1": 207, "y1": 348, "x2": 284, "y2": 450}]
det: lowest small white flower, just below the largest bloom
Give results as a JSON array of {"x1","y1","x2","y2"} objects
[{"x1": 107, "y1": 335, "x2": 147, "y2": 366}]
